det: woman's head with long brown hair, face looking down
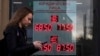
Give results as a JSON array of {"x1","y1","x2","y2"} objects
[{"x1": 8, "y1": 7, "x2": 33, "y2": 26}]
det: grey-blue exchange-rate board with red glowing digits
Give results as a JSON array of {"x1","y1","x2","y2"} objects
[{"x1": 33, "y1": 1, "x2": 76, "y2": 55}]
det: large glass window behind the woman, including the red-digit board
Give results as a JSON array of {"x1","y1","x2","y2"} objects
[{"x1": 10, "y1": 0, "x2": 94, "y2": 56}]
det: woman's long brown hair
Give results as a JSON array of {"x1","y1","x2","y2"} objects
[{"x1": 7, "y1": 7, "x2": 33, "y2": 26}]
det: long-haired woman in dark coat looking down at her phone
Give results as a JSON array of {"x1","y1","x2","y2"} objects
[{"x1": 4, "y1": 7, "x2": 42, "y2": 56}]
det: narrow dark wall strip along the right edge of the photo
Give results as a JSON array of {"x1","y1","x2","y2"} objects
[{"x1": 93, "y1": 0, "x2": 100, "y2": 56}]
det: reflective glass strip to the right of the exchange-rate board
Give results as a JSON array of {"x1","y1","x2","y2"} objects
[{"x1": 76, "y1": 0, "x2": 95, "y2": 56}]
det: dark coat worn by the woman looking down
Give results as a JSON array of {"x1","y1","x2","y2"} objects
[{"x1": 4, "y1": 26, "x2": 38, "y2": 56}]
